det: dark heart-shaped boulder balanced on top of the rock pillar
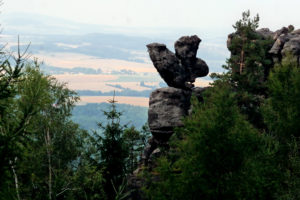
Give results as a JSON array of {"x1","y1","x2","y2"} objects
[{"x1": 147, "y1": 35, "x2": 208, "y2": 89}]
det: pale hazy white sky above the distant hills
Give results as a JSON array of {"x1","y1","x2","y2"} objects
[{"x1": 0, "y1": 0, "x2": 300, "y2": 32}]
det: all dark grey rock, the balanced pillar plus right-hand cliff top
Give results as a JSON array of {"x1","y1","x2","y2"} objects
[{"x1": 128, "y1": 26, "x2": 300, "y2": 199}]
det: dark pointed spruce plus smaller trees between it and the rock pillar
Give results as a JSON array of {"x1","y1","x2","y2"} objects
[{"x1": 92, "y1": 97, "x2": 149, "y2": 199}]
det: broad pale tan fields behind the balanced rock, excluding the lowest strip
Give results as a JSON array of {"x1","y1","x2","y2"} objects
[{"x1": 35, "y1": 52, "x2": 210, "y2": 92}]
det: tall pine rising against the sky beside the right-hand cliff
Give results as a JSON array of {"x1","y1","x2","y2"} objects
[{"x1": 212, "y1": 11, "x2": 273, "y2": 128}]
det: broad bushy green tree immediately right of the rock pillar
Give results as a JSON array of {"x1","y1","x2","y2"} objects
[{"x1": 145, "y1": 84, "x2": 281, "y2": 199}]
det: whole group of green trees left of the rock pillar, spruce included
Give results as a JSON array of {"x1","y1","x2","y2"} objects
[{"x1": 0, "y1": 46, "x2": 149, "y2": 200}]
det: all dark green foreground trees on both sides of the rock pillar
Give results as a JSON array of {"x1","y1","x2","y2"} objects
[{"x1": 0, "y1": 12, "x2": 300, "y2": 200}]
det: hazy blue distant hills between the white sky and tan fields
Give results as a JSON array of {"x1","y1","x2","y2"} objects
[{"x1": 0, "y1": 13, "x2": 229, "y2": 71}]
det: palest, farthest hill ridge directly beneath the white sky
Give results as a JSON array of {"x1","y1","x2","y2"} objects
[{"x1": 0, "y1": 9, "x2": 233, "y2": 39}]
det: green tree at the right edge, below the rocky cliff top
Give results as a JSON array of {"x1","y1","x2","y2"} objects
[{"x1": 262, "y1": 55, "x2": 300, "y2": 199}]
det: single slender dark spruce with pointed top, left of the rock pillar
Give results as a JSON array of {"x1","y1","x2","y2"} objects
[{"x1": 94, "y1": 97, "x2": 128, "y2": 199}]
